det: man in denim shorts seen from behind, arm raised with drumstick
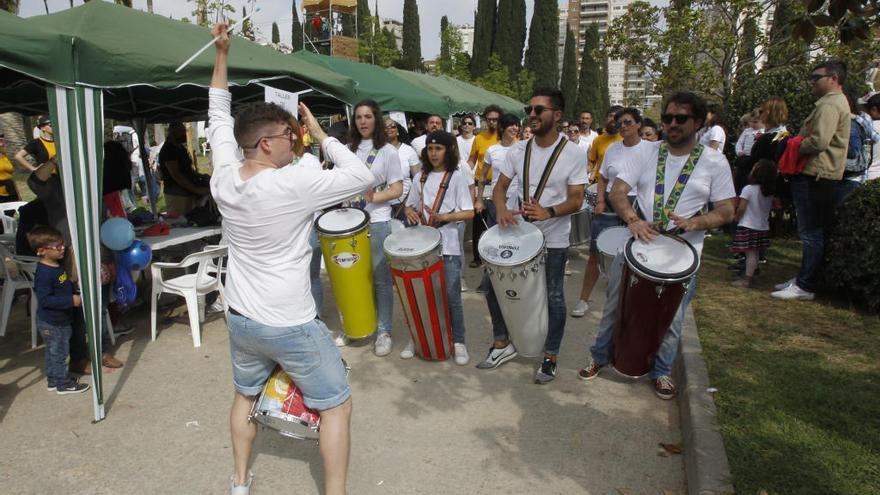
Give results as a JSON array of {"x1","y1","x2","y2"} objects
[{"x1": 208, "y1": 24, "x2": 373, "y2": 495}]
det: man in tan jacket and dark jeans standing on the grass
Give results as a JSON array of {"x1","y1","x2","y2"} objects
[{"x1": 771, "y1": 60, "x2": 852, "y2": 301}]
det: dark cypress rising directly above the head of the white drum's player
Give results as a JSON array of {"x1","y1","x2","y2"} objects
[{"x1": 525, "y1": 0, "x2": 559, "y2": 88}]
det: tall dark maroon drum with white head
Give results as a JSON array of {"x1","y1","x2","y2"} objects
[{"x1": 612, "y1": 234, "x2": 700, "y2": 377}]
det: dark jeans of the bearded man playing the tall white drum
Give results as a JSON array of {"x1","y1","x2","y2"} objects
[{"x1": 484, "y1": 248, "x2": 568, "y2": 356}]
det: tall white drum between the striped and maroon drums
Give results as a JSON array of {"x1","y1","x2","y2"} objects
[{"x1": 478, "y1": 222, "x2": 549, "y2": 357}]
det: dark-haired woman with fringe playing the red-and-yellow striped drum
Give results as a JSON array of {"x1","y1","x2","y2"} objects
[{"x1": 400, "y1": 131, "x2": 474, "y2": 366}]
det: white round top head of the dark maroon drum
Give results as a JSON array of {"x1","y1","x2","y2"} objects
[{"x1": 624, "y1": 234, "x2": 700, "y2": 281}]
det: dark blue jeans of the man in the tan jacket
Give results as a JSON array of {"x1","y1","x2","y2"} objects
[{"x1": 790, "y1": 175, "x2": 840, "y2": 292}]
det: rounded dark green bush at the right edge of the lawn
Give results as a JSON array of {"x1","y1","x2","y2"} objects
[{"x1": 825, "y1": 180, "x2": 880, "y2": 312}]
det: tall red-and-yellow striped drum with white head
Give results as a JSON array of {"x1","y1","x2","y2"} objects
[{"x1": 383, "y1": 225, "x2": 453, "y2": 361}]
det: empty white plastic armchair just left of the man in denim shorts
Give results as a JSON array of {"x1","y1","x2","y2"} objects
[{"x1": 150, "y1": 247, "x2": 226, "y2": 347}]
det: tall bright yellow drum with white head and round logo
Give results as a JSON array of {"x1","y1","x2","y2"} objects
[{"x1": 315, "y1": 208, "x2": 374, "y2": 339}]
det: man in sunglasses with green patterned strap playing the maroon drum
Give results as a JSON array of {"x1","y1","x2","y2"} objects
[{"x1": 578, "y1": 92, "x2": 736, "y2": 399}]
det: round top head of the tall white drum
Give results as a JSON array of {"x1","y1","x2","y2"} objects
[{"x1": 479, "y1": 220, "x2": 544, "y2": 266}]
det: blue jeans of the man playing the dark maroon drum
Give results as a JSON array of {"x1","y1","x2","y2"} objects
[{"x1": 590, "y1": 253, "x2": 697, "y2": 380}]
